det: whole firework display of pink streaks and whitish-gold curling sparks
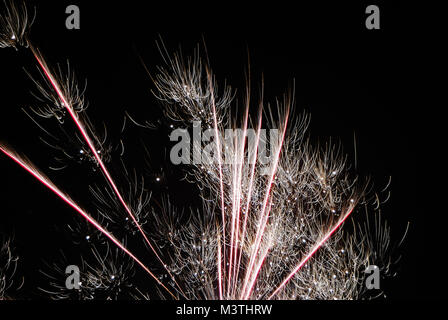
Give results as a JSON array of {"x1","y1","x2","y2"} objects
[{"x1": 0, "y1": 2, "x2": 404, "y2": 300}]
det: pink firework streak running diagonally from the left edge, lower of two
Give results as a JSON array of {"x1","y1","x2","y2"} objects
[{"x1": 0, "y1": 145, "x2": 177, "y2": 299}]
